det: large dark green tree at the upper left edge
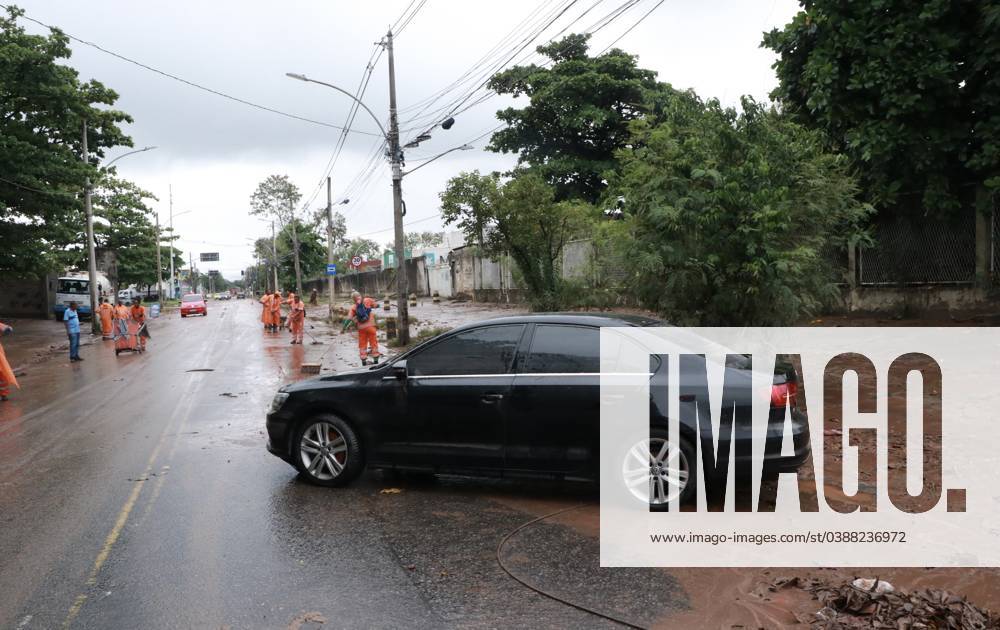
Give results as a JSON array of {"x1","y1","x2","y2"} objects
[{"x1": 0, "y1": 7, "x2": 132, "y2": 275}]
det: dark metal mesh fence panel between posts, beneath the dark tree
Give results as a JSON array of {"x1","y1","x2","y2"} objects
[{"x1": 858, "y1": 208, "x2": 972, "y2": 286}]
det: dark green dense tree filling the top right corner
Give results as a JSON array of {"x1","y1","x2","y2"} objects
[{"x1": 763, "y1": 0, "x2": 1000, "y2": 212}]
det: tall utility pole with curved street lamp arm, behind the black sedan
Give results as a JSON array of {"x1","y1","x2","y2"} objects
[{"x1": 285, "y1": 56, "x2": 455, "y2": 344}]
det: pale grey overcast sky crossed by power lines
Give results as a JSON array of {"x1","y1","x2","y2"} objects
[{"x1": 16, "y1": 0, "x2": 798, "y2": 279}]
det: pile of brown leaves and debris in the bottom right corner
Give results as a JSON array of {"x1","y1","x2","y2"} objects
[{"x1": 773, "y1": 578, "x2": 1000, "y2": 630}]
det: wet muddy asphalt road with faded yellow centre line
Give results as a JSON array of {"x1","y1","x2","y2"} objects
[{"x1": 0, "y1": 301, "x2": 688, "y2": 628}]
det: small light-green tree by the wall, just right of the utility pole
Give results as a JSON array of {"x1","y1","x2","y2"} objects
[{"x1": 440, "y1": 171, "x2": 593, "y2": 310}]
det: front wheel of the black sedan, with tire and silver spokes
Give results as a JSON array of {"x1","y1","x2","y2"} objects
[{"x1": 292, "y1": 414, "x2": 365, "y2": 487}]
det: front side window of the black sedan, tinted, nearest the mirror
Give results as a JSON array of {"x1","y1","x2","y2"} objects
[{"x1": 406, "y1": 324, "x2": 524, "y2": 376}]
